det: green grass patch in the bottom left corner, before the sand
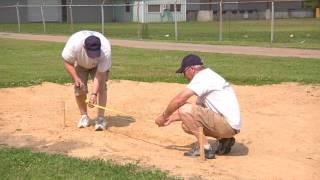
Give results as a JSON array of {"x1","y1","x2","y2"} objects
[{"x1": 0, "y1": 147, "x2": 174, "y2": 180}]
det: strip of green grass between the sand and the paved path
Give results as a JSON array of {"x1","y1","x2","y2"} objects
[{"x1": 0, "y1": 39, "x2": 320, "y2": 87}]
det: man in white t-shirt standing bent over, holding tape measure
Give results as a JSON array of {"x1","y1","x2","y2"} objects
[{"x1": 62, "y1": 31, "x2": 111, "y2": 131}]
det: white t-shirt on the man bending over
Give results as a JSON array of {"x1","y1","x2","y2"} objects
[{"x1": 62, "y1": 31, "x2": 111, "y2": 72}]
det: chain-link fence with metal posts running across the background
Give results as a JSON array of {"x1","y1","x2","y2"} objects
[{"x1": 0, "y1": 0, "x2": 320, "y2": 48}]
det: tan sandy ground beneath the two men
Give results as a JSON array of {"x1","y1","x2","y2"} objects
[{"x1": 0, "y1": 81, "x2": 320, "y2": 179}]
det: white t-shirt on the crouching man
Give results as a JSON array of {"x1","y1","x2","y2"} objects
[{"x1": 187, "y1": 68, "x2": 241, "y2": 130}]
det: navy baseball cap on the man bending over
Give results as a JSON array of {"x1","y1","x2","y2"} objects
[{"x1": 84, "y1": 35, "x2": 101, "y2": 58}]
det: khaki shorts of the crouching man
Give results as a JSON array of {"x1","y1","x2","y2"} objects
[{"x1": 192, "y1": 105, "x2": 237, "y2": 139}]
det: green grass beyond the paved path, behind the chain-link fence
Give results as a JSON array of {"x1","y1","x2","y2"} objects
[{"x1": 0, "y1": 18, "x2": 320, "y2": 49}]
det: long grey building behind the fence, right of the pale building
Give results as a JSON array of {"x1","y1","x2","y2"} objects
[{"x1": 187, "y1": 0, "x2": 313, "y2": 21}]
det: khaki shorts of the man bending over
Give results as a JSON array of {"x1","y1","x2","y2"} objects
[{"x1": 74, "y1": 66, "x2": 107, "y2": 96}]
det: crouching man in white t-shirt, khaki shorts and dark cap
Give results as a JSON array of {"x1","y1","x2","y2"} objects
[{"x1": 155, "y1": 54, "x2": 241, "y2": 159}]
